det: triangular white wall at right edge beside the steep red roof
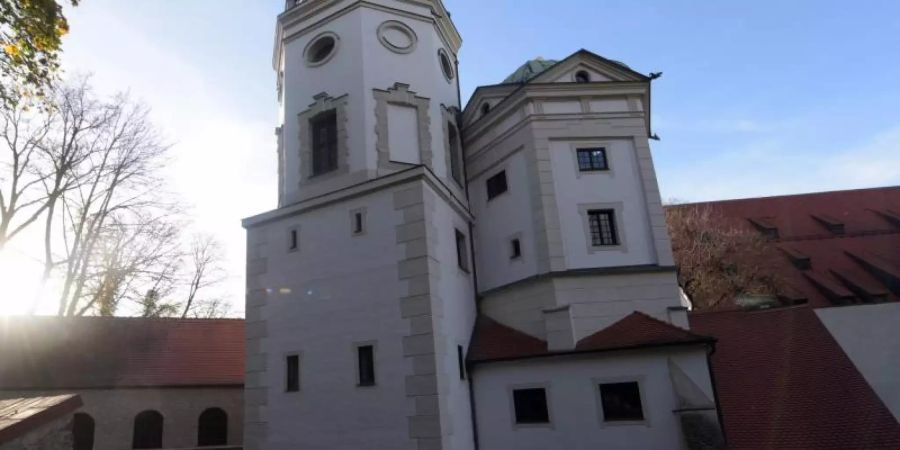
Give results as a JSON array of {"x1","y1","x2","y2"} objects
[{"x1": 816, "y1": 303, "x2": 900, "y2": 421}]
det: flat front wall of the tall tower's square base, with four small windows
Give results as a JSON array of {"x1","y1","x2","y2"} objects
[{"x1": 255, "y1": 190, "x2": 412, "y2": 449}]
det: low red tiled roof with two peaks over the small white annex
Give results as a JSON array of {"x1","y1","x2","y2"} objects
[{"x1": 468, "y1": 311, "x2": 713, "y2": 363}]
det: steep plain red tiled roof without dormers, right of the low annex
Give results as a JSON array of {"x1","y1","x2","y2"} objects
[{"x1": 690, "y1": 306, "x2": 900, "y2": 450}]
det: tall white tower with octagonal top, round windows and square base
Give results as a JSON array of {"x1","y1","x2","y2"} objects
[{"x1": 244, "y1": 0, "x2": 475, "y2": 450}]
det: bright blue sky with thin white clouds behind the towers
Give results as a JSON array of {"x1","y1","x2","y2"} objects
[{"x1": 3, "y1": 0, "x2": 900, "y2": 315}]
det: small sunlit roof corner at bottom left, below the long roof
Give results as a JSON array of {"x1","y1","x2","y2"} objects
[{"x1": 0, "y1": 394, "x2": 82, "y2": 445}]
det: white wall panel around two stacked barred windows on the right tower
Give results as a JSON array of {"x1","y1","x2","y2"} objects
[{"x1": 550, "y1": 139, "x2": 656, "y2": 269}]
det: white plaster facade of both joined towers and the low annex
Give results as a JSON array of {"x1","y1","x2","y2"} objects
[{"x1": 244, "y1": 0, "x2": 715, "y2": 450}]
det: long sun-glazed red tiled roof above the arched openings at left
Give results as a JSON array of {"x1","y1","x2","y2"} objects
[{"x1": 0, "y1": 317, "x2": 244, "y2": 389}]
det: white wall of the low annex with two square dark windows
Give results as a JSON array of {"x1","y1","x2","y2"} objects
[{"x1": 474, "y1": 348, "x2": 713, "y2": 450}]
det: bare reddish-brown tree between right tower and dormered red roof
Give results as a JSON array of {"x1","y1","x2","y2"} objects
[{"x1": 666, "y1": 205, "x2": 784, "y2": 310}]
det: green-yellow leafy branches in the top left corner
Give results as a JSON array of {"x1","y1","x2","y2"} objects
[{"x1": 0, "y1": 0, "x2": 79, "y2": 103}]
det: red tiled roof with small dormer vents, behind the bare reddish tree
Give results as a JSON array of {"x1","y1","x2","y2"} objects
[{"x1": 677, "y1": 186, "x2": 900, "y2": 308}]
